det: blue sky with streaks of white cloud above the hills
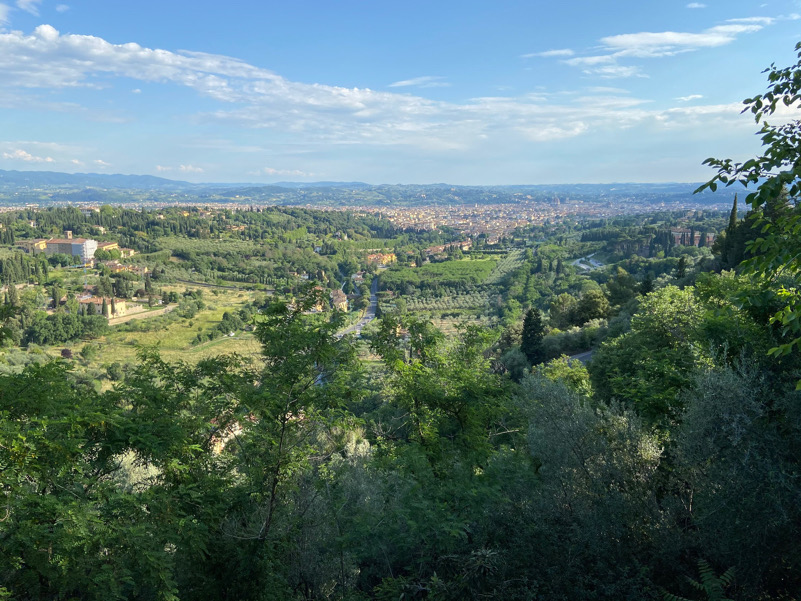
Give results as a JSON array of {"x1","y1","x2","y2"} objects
[{"x1": 0, "y1": 0, "x2": 801, "y2": 184}]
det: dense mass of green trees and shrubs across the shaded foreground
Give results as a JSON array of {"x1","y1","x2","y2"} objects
[{"x1": 0, "y1": 41, "x2": 801, "y2": 601}]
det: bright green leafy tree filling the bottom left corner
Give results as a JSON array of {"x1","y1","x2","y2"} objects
[{"x1": 0, "y1": 362, "x2": 183, "y2": 601}]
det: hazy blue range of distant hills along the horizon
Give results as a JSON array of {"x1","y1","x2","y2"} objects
[{"x1": 0, "y1": 170, "x2": 733, "y2": 207}]
